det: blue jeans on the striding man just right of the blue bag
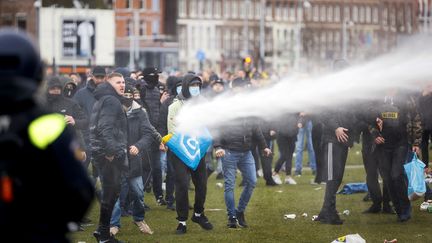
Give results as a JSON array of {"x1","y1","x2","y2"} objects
[{"x1": 222, "y1": 150, "x2": 257, "y2": 217}]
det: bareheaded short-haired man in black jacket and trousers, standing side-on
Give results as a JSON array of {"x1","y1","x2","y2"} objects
[{"x1": 90, "y1": 73, "x2": 128, "y2": 242}]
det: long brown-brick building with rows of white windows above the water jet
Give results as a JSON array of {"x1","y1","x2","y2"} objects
[{"x1": 178, "y1": 0, "x2": 418, "y2": 72}]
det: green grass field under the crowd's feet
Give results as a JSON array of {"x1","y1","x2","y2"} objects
[{"x1": 72, "y1": 147, "x2": 432, "y2": 243}]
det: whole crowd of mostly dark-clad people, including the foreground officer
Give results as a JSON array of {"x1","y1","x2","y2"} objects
[{"x1": 0, "y1": 29, "x2": 432, "y2": 242}]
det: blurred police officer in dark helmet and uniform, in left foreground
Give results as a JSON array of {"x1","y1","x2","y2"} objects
[{"x1": 0, "y1": 29, "x2": 93, "y2": 242}]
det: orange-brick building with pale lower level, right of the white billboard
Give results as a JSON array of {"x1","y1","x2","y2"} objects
[{"x1": 114, "y1": 0, "x2": 178, "y2": 70}]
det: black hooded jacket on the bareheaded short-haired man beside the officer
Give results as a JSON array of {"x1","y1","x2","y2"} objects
[{"x1": 90, "y1": 83, "x2": 128, "y2": 158}]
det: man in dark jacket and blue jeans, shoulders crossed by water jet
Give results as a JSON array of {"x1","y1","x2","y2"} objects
[{"x1": 214, "y1": 78, "x2": 271, "y2": 228}]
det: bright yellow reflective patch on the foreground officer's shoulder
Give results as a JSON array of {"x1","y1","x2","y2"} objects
[{"x1": 28, "y1": 114, "x2": 66, "y2": 149}]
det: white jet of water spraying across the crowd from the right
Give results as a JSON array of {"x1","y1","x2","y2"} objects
[{"x1": 176, "y1": 36, "x2": 432, "y2": 133}]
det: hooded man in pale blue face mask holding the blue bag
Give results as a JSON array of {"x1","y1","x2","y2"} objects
[{"x1": 167, "y1": 74, "x2": 213, "y2": 234}]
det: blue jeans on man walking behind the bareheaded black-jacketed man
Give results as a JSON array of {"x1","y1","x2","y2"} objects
[{"x1": 110, "y1": 176, "x2": 144, "y2": 228}]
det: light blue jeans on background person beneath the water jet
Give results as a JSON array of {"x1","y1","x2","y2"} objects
[{"x1": 295, "y1": 121, "x2": 316, "y2": 174}]
